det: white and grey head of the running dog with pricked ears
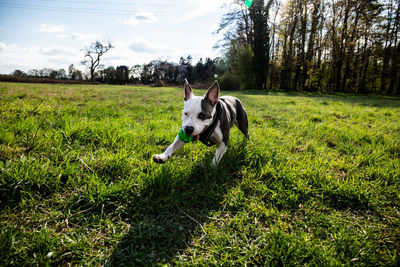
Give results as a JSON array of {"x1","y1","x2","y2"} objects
[{"x1": 182, "y1": 79, "x2": 219, "y2": 140}]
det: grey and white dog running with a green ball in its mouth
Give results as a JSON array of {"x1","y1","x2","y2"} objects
[{"x1": 153, "y1": 79, "x2": 249, "y2": 166}]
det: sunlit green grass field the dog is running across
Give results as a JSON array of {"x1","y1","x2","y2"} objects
[{"x1": 0, "y1": 83, "x2": 400, "y2": 266}]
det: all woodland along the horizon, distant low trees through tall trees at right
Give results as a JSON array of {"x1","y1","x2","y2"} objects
[{"x1": 7, "y1": 0, "x2": 400, "y2": 94}]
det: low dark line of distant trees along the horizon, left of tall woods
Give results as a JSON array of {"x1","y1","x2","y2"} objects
[{"x1": 11, "y1": 55, "x2": 223, "y2": 86}]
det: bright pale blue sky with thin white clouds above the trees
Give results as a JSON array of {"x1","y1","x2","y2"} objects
[{"x1": 0, "y1": 0, "x2": 231, "y2": 74}]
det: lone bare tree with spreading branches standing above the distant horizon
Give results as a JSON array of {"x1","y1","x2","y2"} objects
[{"x1": 81, "y1": 41, "x2": 113, "y2": 82}]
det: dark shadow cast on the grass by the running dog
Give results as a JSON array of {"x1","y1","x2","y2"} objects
[{"x1": 106, "y1": 141, "x2": 246, "y2": 266}]
